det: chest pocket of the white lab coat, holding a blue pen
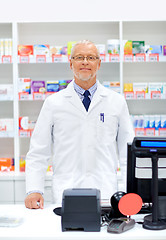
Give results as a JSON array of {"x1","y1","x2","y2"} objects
[{"x1": 97, "y1": 113, "x2": 118, "y2": 143}]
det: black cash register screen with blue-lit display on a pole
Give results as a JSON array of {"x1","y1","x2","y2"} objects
[{"x1": 127, "y1": 137, "x2": 166, "y2": 230}]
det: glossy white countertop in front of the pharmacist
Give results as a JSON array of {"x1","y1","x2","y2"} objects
[{"x1": 0, "y1": 205, "x2": 166, "y2": 240}]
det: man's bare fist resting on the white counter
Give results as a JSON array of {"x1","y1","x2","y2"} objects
[{"x1": 25, "y1": 193, "x2": 44, "y2": 209}]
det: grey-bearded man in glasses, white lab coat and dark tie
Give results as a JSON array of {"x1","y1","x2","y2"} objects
[{"x1": 25, "y1": 40, "x2": 134, "y2": 208}]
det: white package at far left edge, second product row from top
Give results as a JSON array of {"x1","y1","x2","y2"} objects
[{"x1": 0, "y1": 84, "x2": 13, "y2": 100}]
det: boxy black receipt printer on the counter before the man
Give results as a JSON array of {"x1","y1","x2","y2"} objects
[{"x1": 61, "y1": 188, "x2": 101, "y2": 232}]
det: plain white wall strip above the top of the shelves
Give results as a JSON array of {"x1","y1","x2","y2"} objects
[{"x1": 0, "y1": 0, "x2": 166, "y2": 22}]
